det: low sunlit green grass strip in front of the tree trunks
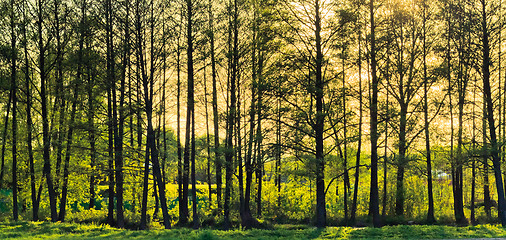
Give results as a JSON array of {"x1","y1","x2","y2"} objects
[{"x1": 0, "y1": 222, "x2": 506, "y2": 240}]
